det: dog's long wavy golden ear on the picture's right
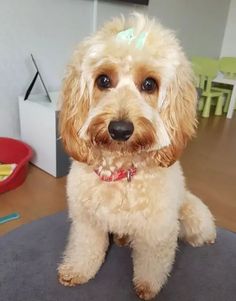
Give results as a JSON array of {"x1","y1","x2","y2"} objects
[{"x1": 154, "y1": 59, "x2": 197, "y2": 167}]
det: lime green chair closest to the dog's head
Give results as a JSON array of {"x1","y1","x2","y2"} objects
[{"x1": 191, "y1": 57, "x2": 224, "y2": 118}]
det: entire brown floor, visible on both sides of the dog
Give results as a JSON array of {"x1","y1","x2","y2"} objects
[{"x1": 0, "y1": 116, "x2": 236, "y2": 235}]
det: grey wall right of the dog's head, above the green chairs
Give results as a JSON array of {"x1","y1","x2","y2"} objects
[{"x1": 149, "y1": 0, "x2": 230, "y2": 57}]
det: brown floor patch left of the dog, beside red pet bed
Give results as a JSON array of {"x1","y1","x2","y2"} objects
[{"x1": 0, "y1": 165, "x2": 66, "y2": 235}]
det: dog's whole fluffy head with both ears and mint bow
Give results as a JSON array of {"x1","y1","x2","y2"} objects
[{"x1": 60, "y1": 15, "x2": 196, "y2": 166}]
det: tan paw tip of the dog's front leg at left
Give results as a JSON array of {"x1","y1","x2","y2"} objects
[{"x1": 58, "y1": 264, "x2": 89, "y2": 286}]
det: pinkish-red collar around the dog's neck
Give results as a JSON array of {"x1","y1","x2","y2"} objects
[{"x1": 94, "y1": 167, "x2": 137, "y2": 182}]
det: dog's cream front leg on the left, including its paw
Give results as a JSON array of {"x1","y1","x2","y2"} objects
[{"x1": 58, "y1": 221, "x2": 108, "y2": 286}]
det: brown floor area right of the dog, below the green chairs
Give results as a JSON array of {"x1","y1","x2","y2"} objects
[{"x1": 181, "y1": 114, "x2": 236, "y2": 232}]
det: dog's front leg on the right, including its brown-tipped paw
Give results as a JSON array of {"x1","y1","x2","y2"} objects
[{"x1": 132, "y1": 227, "x2": 178, "y2": 300}]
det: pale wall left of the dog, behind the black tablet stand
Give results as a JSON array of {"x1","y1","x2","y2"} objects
[{"x1": 0, "y1": 0, "x2": 93, "y2": 138}]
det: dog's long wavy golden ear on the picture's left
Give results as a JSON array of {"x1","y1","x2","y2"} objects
[{"x1": 59, "y1": 65, "x2": 92, "y2": 164}]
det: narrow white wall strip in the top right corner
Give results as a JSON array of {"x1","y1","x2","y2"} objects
[{"x1": 221, "y1": 0, "x2": 236, "y2": 57}]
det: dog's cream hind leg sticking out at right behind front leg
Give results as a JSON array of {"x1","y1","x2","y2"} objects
[{"x1": 179, "y1": 191, "x2": 216, "y2": 247}]
